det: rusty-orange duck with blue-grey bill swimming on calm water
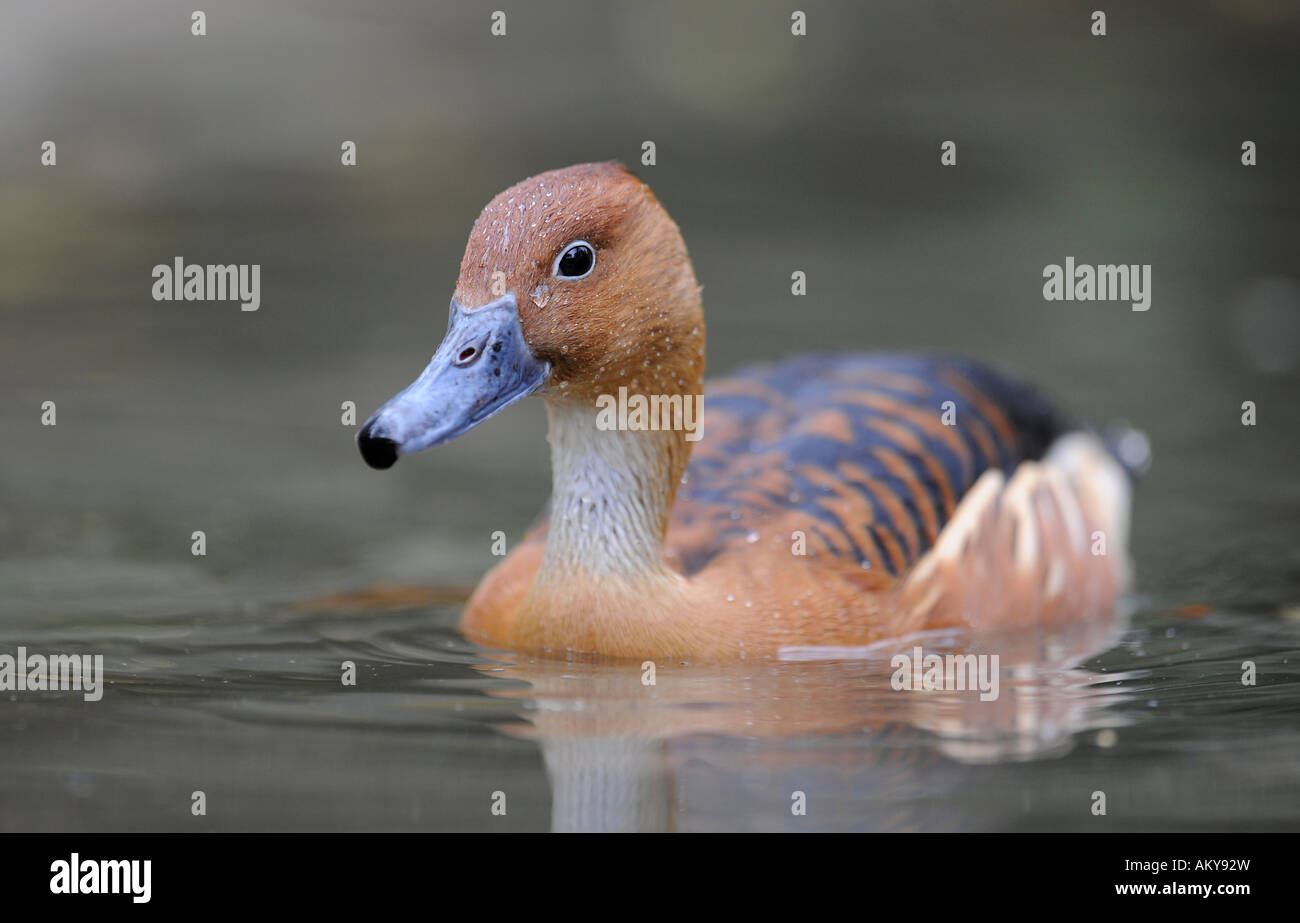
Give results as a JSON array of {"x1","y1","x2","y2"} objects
[{"x1": 356, "y1": 163, "x2": 1134, "y2": 662}]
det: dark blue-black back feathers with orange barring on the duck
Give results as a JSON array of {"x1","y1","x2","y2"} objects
[{"x1": 673, "y1": 355, "x2": 1069, "y2": 576}]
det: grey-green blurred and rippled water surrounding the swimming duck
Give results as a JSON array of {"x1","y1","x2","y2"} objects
[{"x1": 0, "y1": 1, "x2": 1300, "y2": 831}]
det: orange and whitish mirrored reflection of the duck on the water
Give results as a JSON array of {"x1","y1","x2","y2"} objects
[{"x1": 478, "y1": 619, "x2": 1131, "y2": 832}]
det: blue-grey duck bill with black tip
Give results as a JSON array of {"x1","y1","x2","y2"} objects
[{"x1": 356, "y1": 294, "x2": 551, "y2": 468}]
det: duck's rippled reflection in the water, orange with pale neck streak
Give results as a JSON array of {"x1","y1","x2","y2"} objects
[{"x1": 480, "y1": 611, "x2": 1134, "y2": 832}]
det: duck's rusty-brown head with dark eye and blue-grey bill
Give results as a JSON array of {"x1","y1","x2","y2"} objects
[{"x1": 358, "y1": 164, "x2": 705, "y2": 468}]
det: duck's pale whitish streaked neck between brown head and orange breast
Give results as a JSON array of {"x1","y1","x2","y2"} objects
[{"x1": 537, "y1": 400, "x2": 690, "y2": 584}]
